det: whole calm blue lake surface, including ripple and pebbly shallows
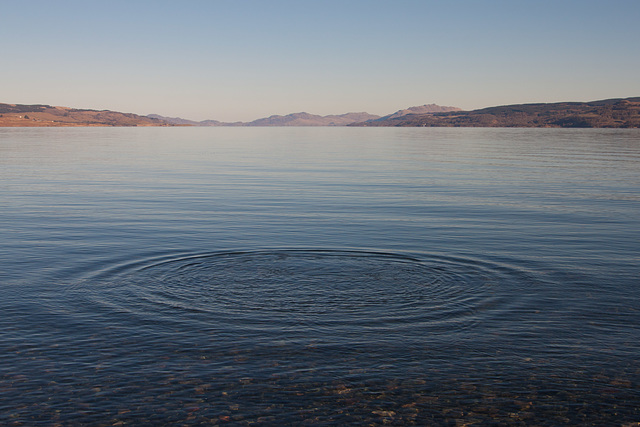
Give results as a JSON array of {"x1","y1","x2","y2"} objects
[{"x1": 0, "y1": 128, "x2": 640, "y2": 425}]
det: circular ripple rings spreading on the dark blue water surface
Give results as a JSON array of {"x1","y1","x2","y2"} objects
[{"x1": 67, "y1": 250, "x2": 523, "y2": 340}]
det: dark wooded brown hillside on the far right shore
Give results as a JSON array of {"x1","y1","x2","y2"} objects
[{"x1": 352, "y1": 98, "x2": 640, "y2": 128}]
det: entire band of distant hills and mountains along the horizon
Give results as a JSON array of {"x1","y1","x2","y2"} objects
[{"x1": 0, "y1": 97, "x2": 640, "y2": 128}]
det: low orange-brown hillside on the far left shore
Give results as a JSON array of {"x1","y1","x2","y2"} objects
[{"x1": 0, "y1": 104, "x2": 172, "y2": 127}]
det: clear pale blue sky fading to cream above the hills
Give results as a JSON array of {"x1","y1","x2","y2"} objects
[{"x1": 0, "y1": 0, "x2": 640, "y2": 121}]
